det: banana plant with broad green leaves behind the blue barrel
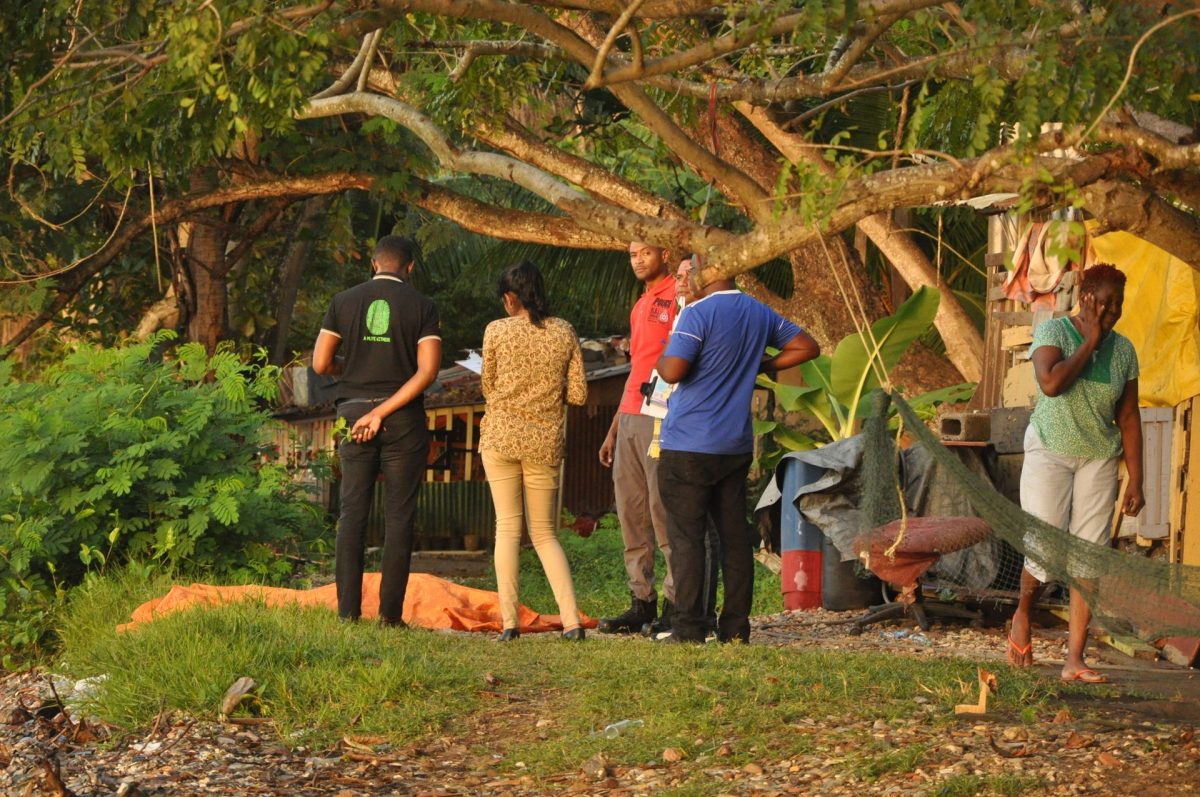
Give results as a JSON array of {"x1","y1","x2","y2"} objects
[{"x1": 755, "y1": 287, "x2": 976, "y2": 451}]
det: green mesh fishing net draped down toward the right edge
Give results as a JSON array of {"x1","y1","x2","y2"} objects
[{"x1": 859, "y1": 390, "x2": 1200, "y2": 640}]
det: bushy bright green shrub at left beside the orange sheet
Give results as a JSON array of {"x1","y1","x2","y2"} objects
[{"x1": 0, "y1": 335, "x2": 320, "y2": 654}]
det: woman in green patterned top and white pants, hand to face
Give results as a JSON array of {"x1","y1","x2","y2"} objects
[{"x1": 1008, "y1": 264, "x2": 1146, "y2": 683}]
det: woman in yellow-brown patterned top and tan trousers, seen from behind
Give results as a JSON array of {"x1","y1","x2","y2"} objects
[{"x1": 479, "y1": 260, "x2": 588, "y2": 642}]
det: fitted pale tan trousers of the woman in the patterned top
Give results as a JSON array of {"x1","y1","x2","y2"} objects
[{"x1": 479, "y1": 450, "x2": 580, "y2": 630}]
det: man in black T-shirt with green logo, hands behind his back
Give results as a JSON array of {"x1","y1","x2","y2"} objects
[{"x1": 312, "y1": 235, "x2": 442, "y2": 625}]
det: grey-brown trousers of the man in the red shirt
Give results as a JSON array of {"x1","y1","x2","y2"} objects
[{"x1": 612, "y1": 413, "x2": 674, "y2": 603}]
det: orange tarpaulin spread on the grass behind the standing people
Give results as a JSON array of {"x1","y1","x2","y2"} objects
[{"x1": 116, "y1": 573, "x2": 596, "y2": 634}]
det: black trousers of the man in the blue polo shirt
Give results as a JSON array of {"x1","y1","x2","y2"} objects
[{"x1": 659, "y1": 449, "x2": 755, "y2": 642}]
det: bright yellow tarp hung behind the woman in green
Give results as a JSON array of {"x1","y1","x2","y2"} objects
[{"x1": 1092, "y1": 232, "x2": 1200, "y2": 407}]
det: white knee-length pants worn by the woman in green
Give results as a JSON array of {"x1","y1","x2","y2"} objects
[{"x1": 1021, "y1": 424, "x2": 1120, "y2": 582}]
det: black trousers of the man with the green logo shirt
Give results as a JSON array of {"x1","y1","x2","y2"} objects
[{"x1": 334, "y1": 401, "x2": 430, "y2": 621}]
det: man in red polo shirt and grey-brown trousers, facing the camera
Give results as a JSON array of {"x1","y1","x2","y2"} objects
[{"x1": 599, "y1": 241, "x2": 677, "y2": 634}]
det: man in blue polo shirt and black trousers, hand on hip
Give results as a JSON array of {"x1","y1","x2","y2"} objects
[{"x1": 658, "y1": 269, "x2": 821, "y2": 642}]
